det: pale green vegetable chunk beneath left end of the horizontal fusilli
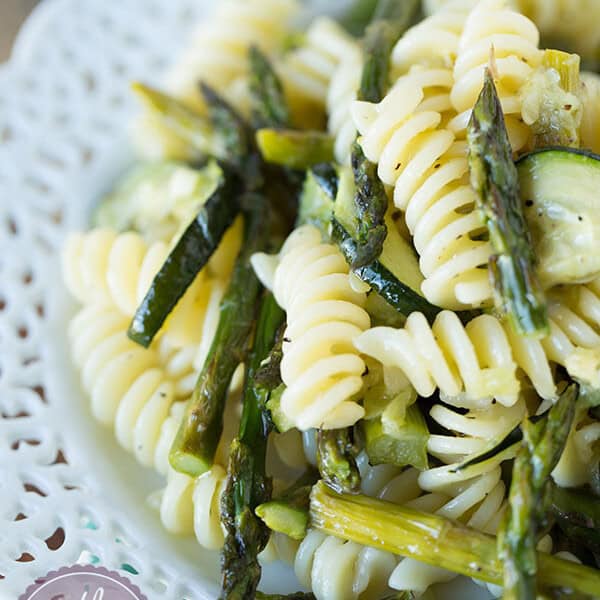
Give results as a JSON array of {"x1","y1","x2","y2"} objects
[{"x1": 363, "y1": 404, "x2": 429, "y2": 470}]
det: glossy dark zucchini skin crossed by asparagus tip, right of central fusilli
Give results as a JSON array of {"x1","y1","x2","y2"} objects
[{"x1": 331, "y1": 218, "x2": 441, "y2": 322}]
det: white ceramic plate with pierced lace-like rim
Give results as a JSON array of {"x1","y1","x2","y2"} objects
[{"x1": 0, "y1": 0, "x2": 492, "y2": 600}]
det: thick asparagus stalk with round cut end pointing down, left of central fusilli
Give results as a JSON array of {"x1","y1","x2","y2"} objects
[{"x1": 169, "y1": 194, "x2": 269, "y2": 477}]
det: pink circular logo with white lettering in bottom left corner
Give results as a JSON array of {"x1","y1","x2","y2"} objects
[{"x1": 19, "y1": 565, "x2": 148, "y2": 600}]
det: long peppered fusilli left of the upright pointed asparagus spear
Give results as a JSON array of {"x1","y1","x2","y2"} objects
[{"x1": 352, "y1": 68, "x2": 492, "y2": 309}]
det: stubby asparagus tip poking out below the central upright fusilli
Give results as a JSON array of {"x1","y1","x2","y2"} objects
[{"x1": 317, "y1": 427, "x2": 360, "y2": 493}]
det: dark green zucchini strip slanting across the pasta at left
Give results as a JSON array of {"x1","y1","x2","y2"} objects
[{"x1": 127, "y1": 177, "x2": 240, "y2": 348}]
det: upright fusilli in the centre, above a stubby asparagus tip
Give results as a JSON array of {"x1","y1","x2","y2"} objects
[{"x1": 262, "y1": 225, "x2": 370, "y2": 431}]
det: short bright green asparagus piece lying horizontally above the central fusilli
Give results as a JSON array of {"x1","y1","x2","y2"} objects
[{"x1": 256, "y1": 129, "x2": 333, "y2": 169}]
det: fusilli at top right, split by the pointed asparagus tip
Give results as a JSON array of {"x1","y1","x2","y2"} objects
[{"x1": 450, "y1": 0, "x2": 543, "y2": 152}]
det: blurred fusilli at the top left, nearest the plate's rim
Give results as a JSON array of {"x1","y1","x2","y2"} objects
[{"x1": 166, "y1": 0, "x2": 297, "y2": 110}]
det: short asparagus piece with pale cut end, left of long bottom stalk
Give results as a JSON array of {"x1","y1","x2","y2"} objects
[{"x1": 255, "y1": 468, "x2": 319, "y2": 540}]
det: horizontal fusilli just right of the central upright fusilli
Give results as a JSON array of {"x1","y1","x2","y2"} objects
[{"x1": 355, "y1": 311, "x2": 556, "y2": 408}]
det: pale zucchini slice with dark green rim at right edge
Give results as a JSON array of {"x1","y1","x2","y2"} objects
[{"x1": 517, "y1": 148, "x2": 600, "y2": 288}]
